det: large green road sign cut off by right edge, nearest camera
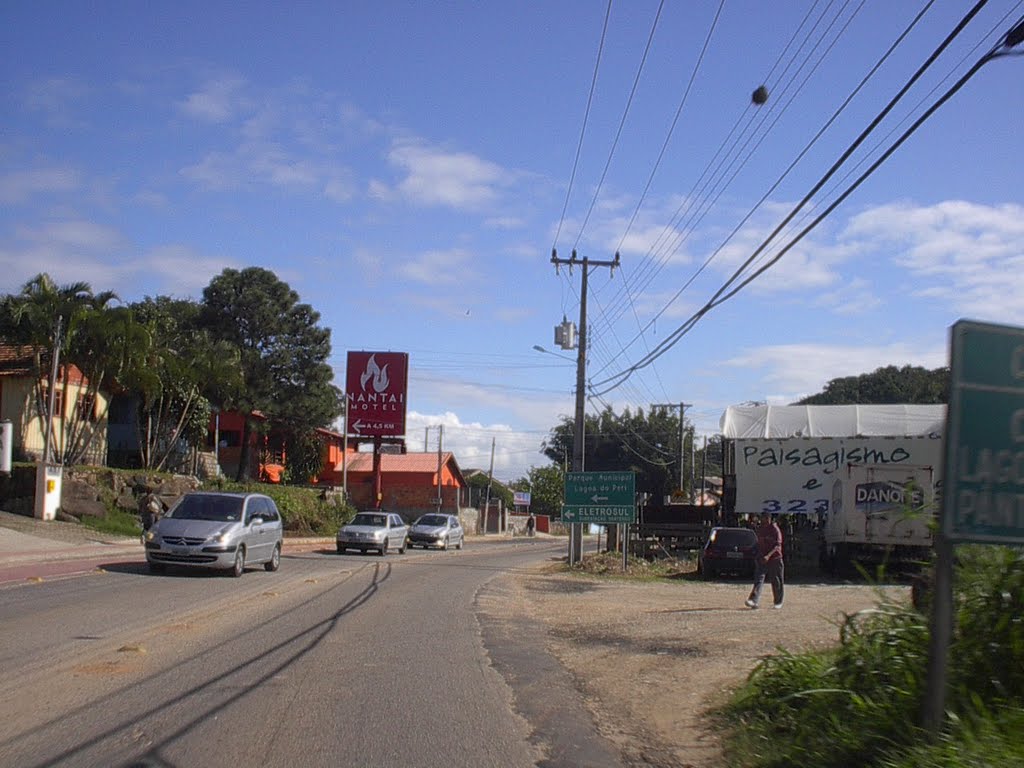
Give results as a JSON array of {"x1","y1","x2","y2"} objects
[{"x1": 942, "y1": 321, "x2": 1024, "y2": 544}]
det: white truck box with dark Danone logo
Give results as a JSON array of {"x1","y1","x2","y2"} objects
[{"x1": 821, "y1": 464, "x2": 937, "y2": 573}]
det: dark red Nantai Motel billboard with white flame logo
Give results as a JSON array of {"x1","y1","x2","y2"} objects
[{"x1": 345, "y1": 352, "x2": 409, "y2": 437}]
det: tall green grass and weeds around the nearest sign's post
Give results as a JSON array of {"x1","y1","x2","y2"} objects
[{"x1": 716, "y1": 547, "x2": 1024, "y2": 768}]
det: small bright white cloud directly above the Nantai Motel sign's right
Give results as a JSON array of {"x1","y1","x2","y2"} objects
[{"x1": 388, "y1": 142, "x2": 509, "y2": 209}]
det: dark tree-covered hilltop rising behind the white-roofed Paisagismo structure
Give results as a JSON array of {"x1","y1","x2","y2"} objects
[{"x1": 796, "y1": 366, "x2": 949, "y2": 406}]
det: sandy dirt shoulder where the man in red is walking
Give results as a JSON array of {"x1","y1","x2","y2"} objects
[{"x1": 506, "y1": 572, "x2": 908, "y2": 768}]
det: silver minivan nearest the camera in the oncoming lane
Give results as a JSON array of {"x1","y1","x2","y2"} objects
[{"x1": 143, "y1": 492, "x2": 284, "y2": 577}]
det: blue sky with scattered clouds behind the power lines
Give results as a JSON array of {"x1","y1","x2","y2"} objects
[{"x1": 0, "y1": 0, "x2": 1024, "y2": 479}]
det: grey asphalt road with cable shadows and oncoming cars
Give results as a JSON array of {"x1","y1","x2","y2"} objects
[{"x1": 0, "y1": 540, "x2": 611, "y2": 768}]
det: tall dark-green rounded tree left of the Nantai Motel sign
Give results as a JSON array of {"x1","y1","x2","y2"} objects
[{"x1": 200, "y1": 267, "x2": 342, "y2": 480}]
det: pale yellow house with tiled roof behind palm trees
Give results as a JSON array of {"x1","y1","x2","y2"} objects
[{"x1": 0, "y1": 344, "x2": 108, "y2": 465}]
